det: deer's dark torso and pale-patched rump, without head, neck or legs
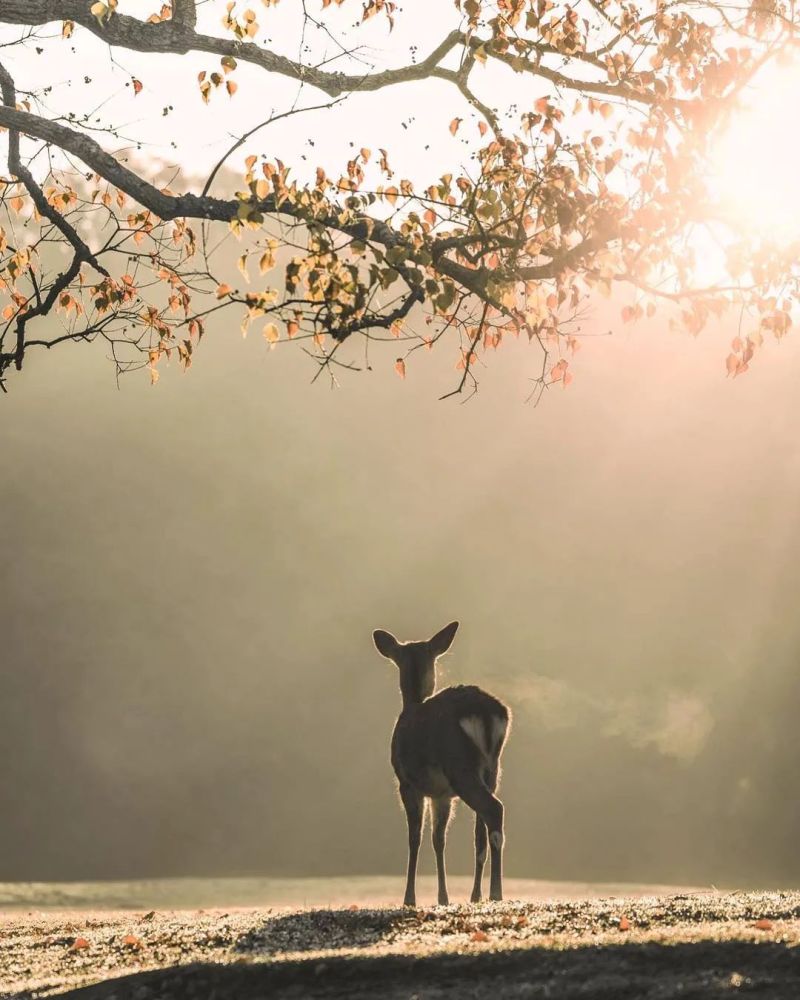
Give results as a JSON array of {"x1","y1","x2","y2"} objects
[{"x1": 392, "y1": 685, "x2": 509, "y2": 796}]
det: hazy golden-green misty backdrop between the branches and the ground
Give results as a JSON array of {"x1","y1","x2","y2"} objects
[{"x1": 0, "y1": 306, "x2": 800, "y2": 886}]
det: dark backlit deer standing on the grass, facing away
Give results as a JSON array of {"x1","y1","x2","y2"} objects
[{"x1": 372, "y1": 621, "x2": 510, "y2": 907}]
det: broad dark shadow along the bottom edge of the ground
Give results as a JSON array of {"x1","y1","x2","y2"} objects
[{"x1": 60, "y1": 936, "x2": 800, "y2": 1000}]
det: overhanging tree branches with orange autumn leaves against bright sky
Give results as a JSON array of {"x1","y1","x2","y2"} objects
[{"x1": 0, "y1": 0, "x2": 798, "y2": 393}]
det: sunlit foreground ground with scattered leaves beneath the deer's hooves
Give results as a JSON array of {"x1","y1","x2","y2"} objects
[{"x1": 0, "y1": 892, "x2": 800, "y2": 1000}]
